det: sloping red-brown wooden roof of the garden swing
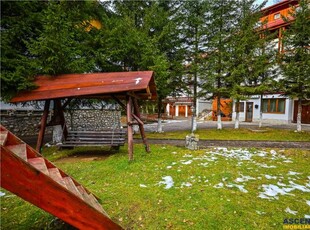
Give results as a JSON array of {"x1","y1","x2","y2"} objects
[{"x1": 11, "y1": 71, "x2": 157, "y2": 102}]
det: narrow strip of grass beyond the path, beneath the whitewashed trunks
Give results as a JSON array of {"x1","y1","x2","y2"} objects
[{"x1": 139, "y1": 128, "x2": 310, "y2": 141}]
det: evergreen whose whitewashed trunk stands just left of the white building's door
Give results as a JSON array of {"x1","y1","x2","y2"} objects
[{"x1": 228, "y1": 0, "x2": 272, "y2": 129}]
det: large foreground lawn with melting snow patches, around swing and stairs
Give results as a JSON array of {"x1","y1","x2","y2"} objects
[{"x1": 1, "y1": 145, "x2": 310, "y2": 229}]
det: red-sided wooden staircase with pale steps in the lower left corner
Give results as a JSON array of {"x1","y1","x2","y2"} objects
[{"x1": 0, "y1": 126, "x2": 122, "y2": 229}]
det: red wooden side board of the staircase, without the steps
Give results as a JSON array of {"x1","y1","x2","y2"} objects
[{"x1": 1, "y1": 146, "x2": 122, "y2": 230}]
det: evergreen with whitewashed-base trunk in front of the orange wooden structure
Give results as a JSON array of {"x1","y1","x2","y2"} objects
[{"x1": 203, "y1": 0, "x2": 237, "y2": 129}]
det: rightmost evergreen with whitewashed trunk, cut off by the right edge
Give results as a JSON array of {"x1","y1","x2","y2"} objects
[{"x1": 280, "y1": 0, "x2": 310, "y2": 131}]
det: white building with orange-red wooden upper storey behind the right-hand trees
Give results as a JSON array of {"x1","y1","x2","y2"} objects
[{"x1": 233, "y1": 0, "x2": 310, "y2": 124}]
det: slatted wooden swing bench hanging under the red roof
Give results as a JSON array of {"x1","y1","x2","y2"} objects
[{"x1": 61, "y1": 129, "x2": 126, "y2": 149}]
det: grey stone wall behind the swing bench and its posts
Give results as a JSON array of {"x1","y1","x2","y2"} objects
[{"x1": 1, "y1": 109, "x2": 121, "y2": 136}]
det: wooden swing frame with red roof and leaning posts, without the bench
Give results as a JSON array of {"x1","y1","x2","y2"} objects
[{"x1": 11, "y1": 71, "x2": 157, "y2": 160}]
